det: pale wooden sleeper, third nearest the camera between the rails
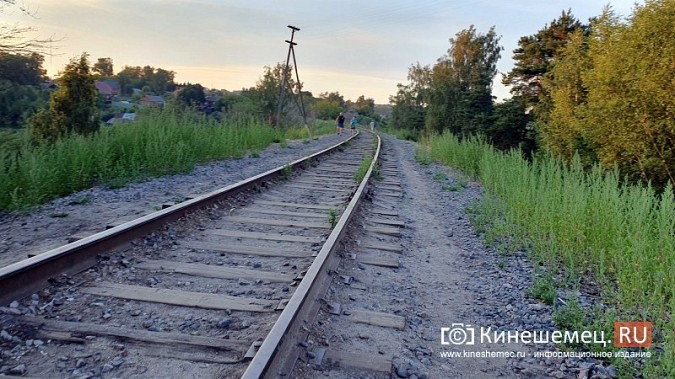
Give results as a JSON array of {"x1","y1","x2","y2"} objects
[{"x1": 134, "y1": 260, "x2": 296, "y2": 283}]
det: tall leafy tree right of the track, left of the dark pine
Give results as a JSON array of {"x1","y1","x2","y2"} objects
[{"x1": 426, "y1": 25, "x2": 502, "y2": 135}]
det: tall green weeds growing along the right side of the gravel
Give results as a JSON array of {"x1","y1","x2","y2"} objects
[{"x1": 418, "y1": 134, "x2": 675, "y2": 378}]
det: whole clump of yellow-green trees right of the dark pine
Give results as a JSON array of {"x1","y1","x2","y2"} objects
[{"x1": 541, "y1": 0, "x2": 675, "y2": 187}]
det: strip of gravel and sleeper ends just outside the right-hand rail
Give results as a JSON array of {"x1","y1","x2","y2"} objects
[{"x1": 291, "y1": 140, "x2": 406, "y2": 379}]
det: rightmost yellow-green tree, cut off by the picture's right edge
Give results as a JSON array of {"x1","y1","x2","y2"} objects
[{"x1": 583, "y1": 0, "x2": 675, "y2": 185}]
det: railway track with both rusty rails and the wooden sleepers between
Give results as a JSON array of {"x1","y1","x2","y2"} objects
[{"x1": 0, "y1": 133, "x2": 387, "y2": 378}]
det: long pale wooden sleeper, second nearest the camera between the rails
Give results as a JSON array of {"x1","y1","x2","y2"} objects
[{"x1": 81, "y1": 282, "x2": 279, "y2": 312}]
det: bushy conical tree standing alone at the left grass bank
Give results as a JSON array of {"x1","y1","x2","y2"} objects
[{"x1": 29, "y1": 53, "x2": 99, "y2": 142}]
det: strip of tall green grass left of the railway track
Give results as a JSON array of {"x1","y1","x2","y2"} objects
[{"x1": 0, "y1": 111, "x2": 332, "y2": 210}]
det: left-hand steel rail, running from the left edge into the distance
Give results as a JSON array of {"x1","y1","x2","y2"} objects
[{"x1": 0, "y1": 133, "x2": 358, "y2": 305}]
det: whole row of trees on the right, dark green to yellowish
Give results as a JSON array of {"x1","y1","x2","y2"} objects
[{"x1": 390, "y1": 0, "x2": 675, "y2": 187}]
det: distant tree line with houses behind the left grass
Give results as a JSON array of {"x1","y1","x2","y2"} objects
[{"x1": 0, "y1": 52, "x2": 380, "y2": 143}]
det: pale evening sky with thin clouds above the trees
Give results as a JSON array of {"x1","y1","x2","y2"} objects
[{"x1": 0, "y1": 0, "x2": 634, "y2": 104}]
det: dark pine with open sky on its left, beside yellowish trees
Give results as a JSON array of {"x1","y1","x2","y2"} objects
[{"x1": 502, "y1": 10, "x2": 588, "y2": 116}]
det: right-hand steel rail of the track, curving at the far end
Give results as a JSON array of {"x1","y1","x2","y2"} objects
[{"x1": 242, "y1": 133, "x2": 382, "y2": 379}]
